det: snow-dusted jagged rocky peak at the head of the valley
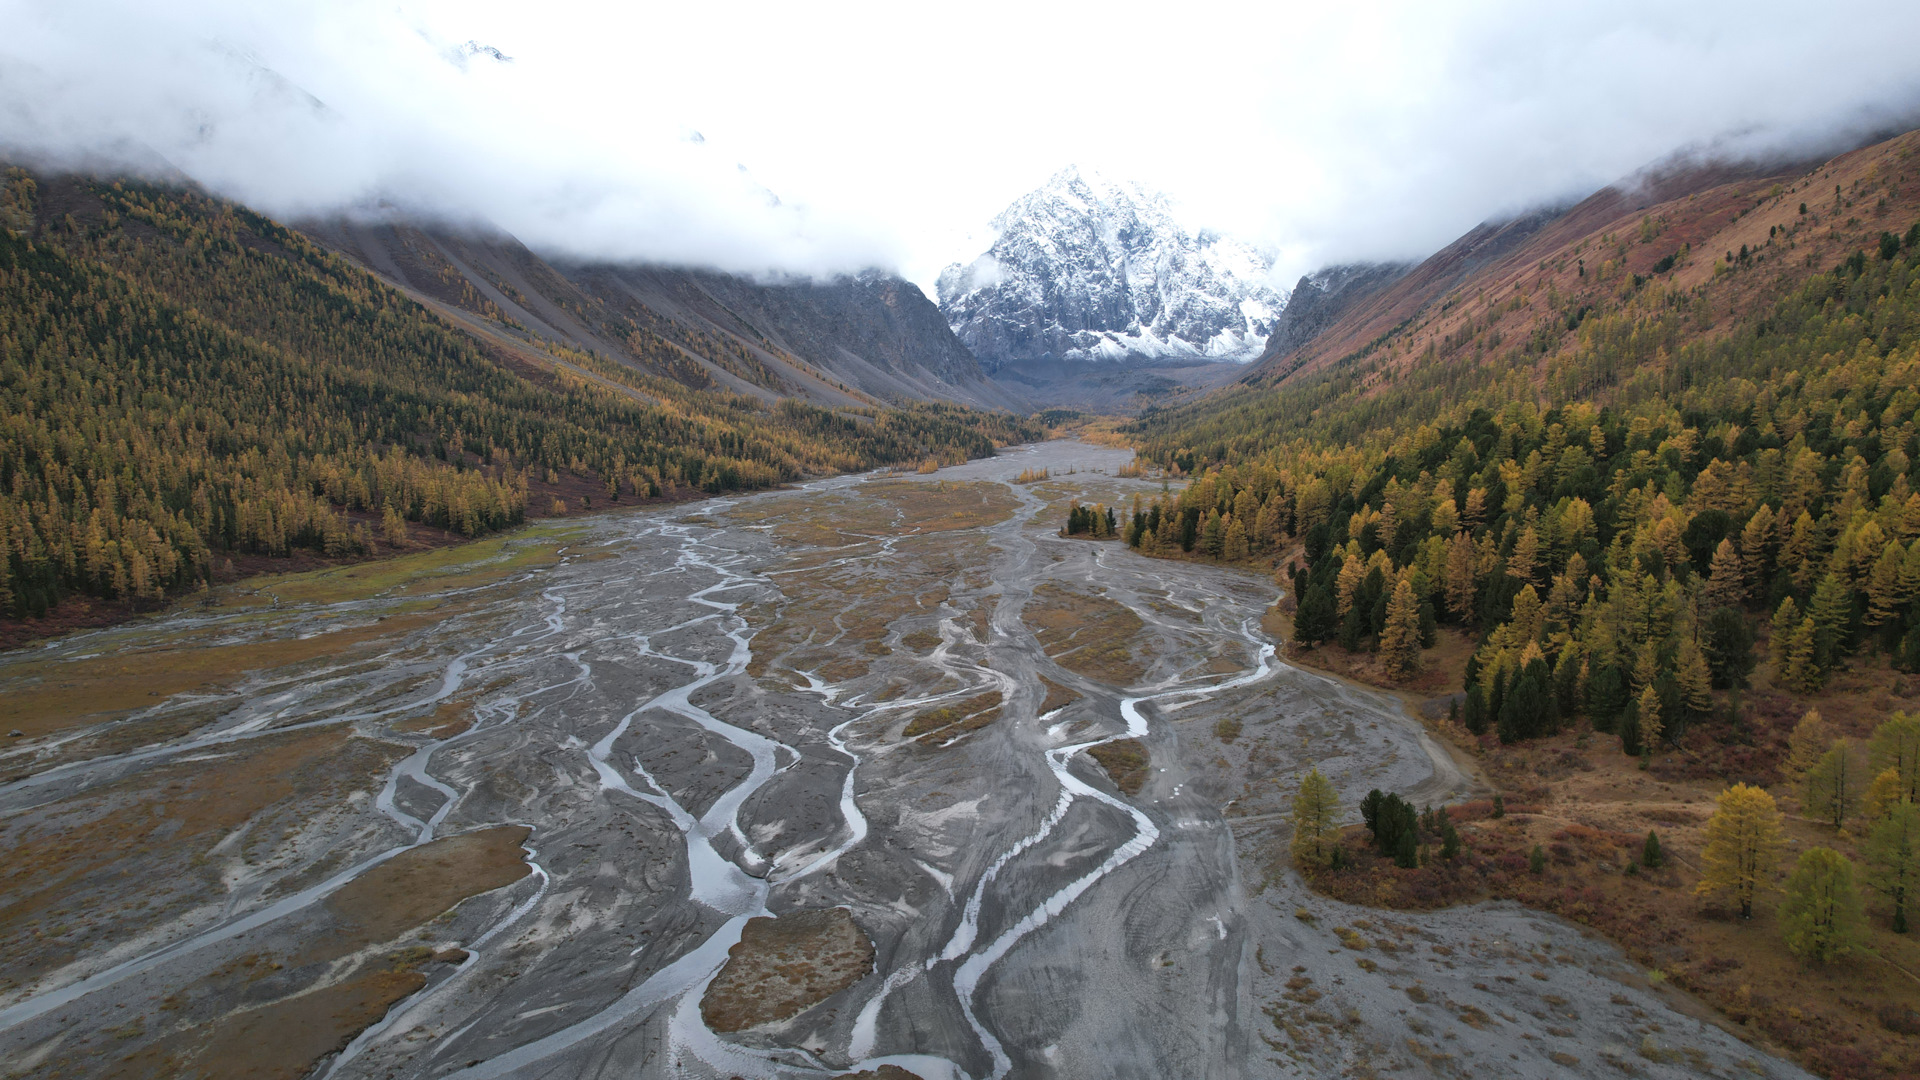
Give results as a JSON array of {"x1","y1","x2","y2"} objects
[{"x1": 939, "y1": 167, "x2": 1286, "y2": 371}]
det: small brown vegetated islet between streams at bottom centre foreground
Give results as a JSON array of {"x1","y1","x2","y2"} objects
[{"x1": 701, "y1": 907, "x2": 874, "y2": 1032}]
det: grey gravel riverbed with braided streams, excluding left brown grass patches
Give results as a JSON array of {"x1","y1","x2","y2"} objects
[{"x1": 0, "y1": 442, "x2": 1803, "y2": 1080}]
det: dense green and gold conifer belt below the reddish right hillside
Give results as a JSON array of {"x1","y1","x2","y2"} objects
[{"x1": 1075, "y1": 222, "x2": 1920, "y2": 753}]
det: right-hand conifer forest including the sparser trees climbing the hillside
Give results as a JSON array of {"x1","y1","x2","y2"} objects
[{"x1": 1121, "y1": 141, "x2": 1920, "y2": 751}]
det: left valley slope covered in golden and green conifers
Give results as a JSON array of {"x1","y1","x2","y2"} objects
[{"x1": 0, "y1": 169, "x2": 1041, "y2": 617}]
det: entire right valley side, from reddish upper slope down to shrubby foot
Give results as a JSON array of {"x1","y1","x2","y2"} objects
[{"x1": 1090, "y1": 123, "x2": 1920, "y2": 1076}]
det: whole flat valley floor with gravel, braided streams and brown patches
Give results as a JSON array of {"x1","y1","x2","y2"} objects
[{"x1": 0, "y1": 442, "x2": 1805, "y2": 1080}]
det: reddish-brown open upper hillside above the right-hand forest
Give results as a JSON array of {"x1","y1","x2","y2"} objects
[{"x1": 1140, "y1": 140, "x2": 1910, "y2": 459}]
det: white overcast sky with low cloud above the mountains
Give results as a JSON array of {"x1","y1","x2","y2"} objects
[{"x1": 0, "y1": 0, "x2": 1920, "y2": 292}]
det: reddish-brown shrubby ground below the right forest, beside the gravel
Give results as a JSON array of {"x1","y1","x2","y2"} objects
[{"x1": 1309, "y1": 728, "x2": 1920, "y2": 1080}]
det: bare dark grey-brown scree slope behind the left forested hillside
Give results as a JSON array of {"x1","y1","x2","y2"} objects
[{"x1": 303, "y1": 219, "x2": 1025, "y2": 411}]
